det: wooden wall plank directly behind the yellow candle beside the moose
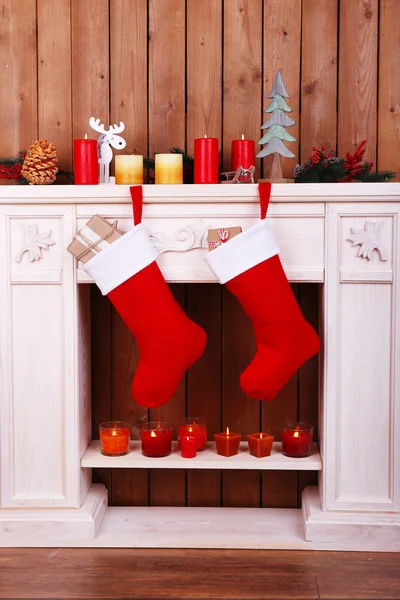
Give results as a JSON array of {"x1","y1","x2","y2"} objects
[{"x1": 110, "y1": 0, "x2": 148, "y2": 156}]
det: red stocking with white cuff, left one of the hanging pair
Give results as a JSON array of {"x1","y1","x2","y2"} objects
[{"x1": 84, "y1": 186, "x2": 206, "y2": 408}]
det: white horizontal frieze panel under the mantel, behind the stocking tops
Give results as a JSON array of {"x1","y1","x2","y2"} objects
[{"x1": 78, "y1": 213, "x2": 324, "y2": 282}]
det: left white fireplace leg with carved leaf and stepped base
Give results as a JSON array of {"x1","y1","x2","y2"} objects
[{"x1": 0, "y1": 205, "x2": 106, "y2": 537}]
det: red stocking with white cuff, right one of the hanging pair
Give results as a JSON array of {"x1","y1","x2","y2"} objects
[{"x1": 205, "y1": 183, "x2": 319, "y2": 400}]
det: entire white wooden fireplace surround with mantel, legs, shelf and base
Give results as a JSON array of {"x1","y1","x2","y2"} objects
[{"x1": 0, "y1": 183, "x2": 400, "y2": 551}]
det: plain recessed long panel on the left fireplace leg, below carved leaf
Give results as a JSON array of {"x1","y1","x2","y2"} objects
[{"x1": 11, "y1": 285, "x2": 65, "y2": 506}]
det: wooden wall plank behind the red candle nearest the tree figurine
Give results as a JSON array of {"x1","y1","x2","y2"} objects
[{"x1": 223, "y1": 0, "x2": 262, "y2": 171}]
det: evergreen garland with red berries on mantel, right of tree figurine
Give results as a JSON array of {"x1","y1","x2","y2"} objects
[{"x1": 293, "y1": 140, "x2": 396, "y2": 183}]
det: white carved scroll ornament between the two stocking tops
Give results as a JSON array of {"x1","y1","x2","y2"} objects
[{"x1": 150, "y1": 219, "x2": 211, "y2": 254}]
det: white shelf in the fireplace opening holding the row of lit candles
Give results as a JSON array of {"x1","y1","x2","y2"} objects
[{"x1": 81, "y1": 441, "x2": 322, "y2": 471}]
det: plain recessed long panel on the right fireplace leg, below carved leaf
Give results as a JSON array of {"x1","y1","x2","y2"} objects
[{"x1": 336, "y1": 284, "x2": 393, "y2": 509}]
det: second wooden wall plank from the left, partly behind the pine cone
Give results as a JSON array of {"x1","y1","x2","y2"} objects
[{"x1": 37, "y1": 0, "x2": 72, "y2": 171}]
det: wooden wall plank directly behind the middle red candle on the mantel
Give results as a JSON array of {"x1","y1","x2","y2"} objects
[{"x1": 186, "y1": 0, "x2": 222, "y2": 153}]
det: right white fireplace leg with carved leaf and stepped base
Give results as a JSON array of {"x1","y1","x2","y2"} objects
[{"x1": 303, "y1": 203, "x2": 400, "y2": 544}]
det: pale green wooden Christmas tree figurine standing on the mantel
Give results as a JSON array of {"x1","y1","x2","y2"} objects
[{"x1": 257, "y1": 69, "x2": 296, "y2": 180}]
